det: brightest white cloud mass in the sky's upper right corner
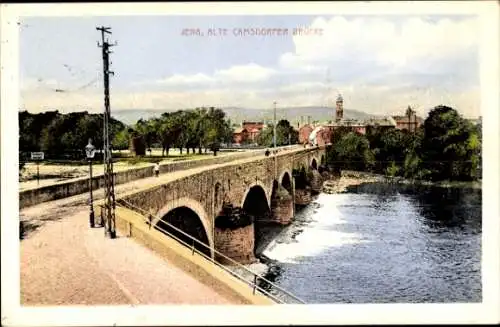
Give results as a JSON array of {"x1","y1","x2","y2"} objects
[{"x1": 280, "y1": 17, "x2": 478, "y2": 72}]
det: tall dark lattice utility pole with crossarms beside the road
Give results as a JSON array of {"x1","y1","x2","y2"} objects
[{"x1": 96, "y1": 26, "x2": 116, "y2": 238}]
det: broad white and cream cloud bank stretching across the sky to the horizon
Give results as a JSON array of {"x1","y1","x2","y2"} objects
[{"x1": 22, "y1": 16, "x2": 480, "y2": 116}]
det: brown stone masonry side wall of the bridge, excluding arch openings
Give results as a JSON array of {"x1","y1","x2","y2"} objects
[{"x1": 117, "y1": 147, "x2": 325, "y2": 261}]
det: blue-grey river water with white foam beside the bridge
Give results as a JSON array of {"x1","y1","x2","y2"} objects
[{"x1": 263, "y1": 183, "x2": 482, "y2": 304}]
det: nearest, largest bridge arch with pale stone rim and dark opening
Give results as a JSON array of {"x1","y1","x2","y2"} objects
[{"x1": 153, "y1": 197, "x2": 214, "y2": 256}]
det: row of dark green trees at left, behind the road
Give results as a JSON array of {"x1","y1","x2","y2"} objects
[{"x1": 19, "y1": 107, "x2": 232, "y2": 158}]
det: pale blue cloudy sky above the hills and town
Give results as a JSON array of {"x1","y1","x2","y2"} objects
[{"x1": 20, "y1": 15, "x2": 481, "y2": 117}]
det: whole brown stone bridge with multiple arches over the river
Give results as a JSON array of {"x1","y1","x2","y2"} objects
[{"x1": 117, "y1": 147, "x2": 326, "y2": 263}]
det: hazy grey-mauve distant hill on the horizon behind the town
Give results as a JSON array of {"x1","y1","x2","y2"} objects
[{"x1": 111, "y1": 106, "x2": 374, "y2": 125}]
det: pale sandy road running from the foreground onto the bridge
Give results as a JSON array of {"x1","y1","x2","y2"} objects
[{"x1": 20, "y1": 145, "x2": 302, "y2": 305}]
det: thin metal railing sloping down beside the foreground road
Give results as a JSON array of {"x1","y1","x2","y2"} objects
[{"x1": 112, "y1": 199, "x2": 305, "y2": 304}]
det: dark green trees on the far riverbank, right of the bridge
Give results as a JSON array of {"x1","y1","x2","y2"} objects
[{"x1": 327, "y1": 106, "x2": 481, "y2": 181}]
